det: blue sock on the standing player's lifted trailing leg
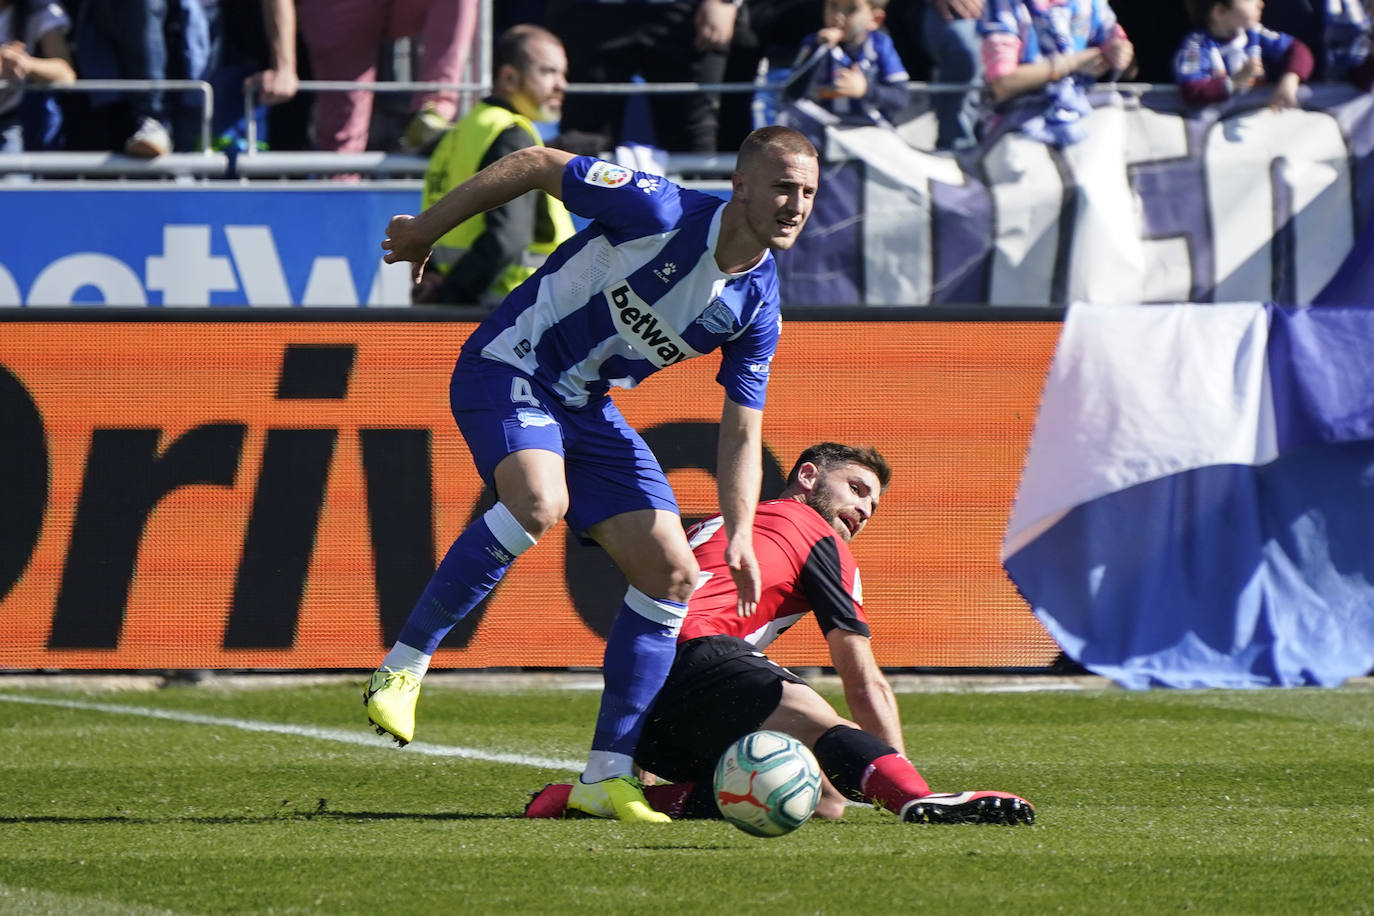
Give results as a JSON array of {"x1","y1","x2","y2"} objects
[{"x1": 397, "y1": 503, "x2": 534, "y2": 655}]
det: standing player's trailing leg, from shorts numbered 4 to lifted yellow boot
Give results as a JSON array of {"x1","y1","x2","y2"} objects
[{"x1": 363, "y1": 360, "x2": 569, "y2": 744}]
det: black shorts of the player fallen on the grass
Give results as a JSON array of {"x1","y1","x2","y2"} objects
[{"x1": 635, "y1": 636, "x2": 807, "y2": 783}]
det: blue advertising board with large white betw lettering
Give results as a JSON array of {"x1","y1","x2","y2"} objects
[{"x1": 0, "y1": 183, "x2": 419, "y2": 308}]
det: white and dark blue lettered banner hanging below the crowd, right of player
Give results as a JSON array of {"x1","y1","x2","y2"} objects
[{"x1": 779, "y1": 87, "x2": 1374, "y2": 308}]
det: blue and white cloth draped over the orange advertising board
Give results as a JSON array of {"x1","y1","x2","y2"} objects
[{"x1": 1003, "y1": 300, "x2": 1374, "y2": 688}]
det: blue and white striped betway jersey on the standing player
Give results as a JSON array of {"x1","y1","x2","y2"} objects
[{"x1": 463, "y1": 157, "x2": 782, "y2": 408}]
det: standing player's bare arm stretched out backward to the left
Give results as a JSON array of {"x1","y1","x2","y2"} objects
[{"x1": 382, "y1": 147, "x2": 573, "y2": 283}]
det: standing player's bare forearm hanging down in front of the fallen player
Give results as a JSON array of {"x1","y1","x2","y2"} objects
[{"x1": 716, "y1": 397, "x2": 764, "y2": 617}]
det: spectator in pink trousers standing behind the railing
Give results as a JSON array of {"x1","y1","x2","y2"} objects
[{"x1": 300, "y1": 0, "x2": 478, "y2": 152}]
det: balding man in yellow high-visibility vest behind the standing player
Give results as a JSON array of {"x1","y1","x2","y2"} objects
[{"x1": 411, "y1": 25, "x2": 573, "y2": 309}]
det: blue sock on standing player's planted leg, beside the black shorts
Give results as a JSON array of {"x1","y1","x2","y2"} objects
[{"x1": 592, "y1": 588, "x2": 687, "y2": 775}]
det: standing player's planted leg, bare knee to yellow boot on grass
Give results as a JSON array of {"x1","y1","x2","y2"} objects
[{"x1": 569, "y1": 508, "x2": 698, "y2": 821}]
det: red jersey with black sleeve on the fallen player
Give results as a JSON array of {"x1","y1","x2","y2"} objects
[{"x1": 677, "y1": 499, "x2": 868, "y2": 650}]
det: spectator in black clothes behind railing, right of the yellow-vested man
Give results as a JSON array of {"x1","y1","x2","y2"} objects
[{"x1": 548, "y1": 0, "x2": 741, "y2": 152}]
